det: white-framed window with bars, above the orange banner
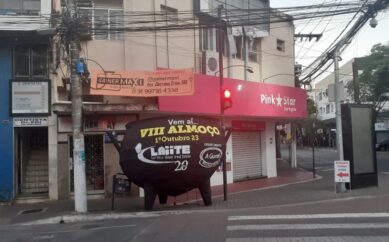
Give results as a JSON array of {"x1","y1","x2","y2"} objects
[{"x1": 80, "y1": 8, "x2": 124, "y2": 40}]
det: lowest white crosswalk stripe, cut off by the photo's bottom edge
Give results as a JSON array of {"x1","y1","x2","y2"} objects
[{"x1": 226, "y1": 236, "x2": 389, "y2": 242}]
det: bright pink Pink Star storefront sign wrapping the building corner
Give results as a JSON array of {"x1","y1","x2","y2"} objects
[{"x1": 158, "y1": 74, "x2": 307, "y2": 119}]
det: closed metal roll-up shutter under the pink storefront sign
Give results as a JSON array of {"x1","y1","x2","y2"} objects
[{"x1": 232, "y1": 132, "x2": 262, "y2": 181}]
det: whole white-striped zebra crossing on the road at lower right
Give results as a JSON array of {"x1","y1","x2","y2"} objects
[{"x1": 226, "y1": 213, "x2": 389, "y2": 242}]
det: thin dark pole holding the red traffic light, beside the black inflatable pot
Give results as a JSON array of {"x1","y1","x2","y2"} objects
[{"x1": 217, "y1": 5, "x2": 227, "y2": 201}]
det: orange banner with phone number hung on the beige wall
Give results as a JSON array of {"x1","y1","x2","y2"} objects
[{"x1": 90, "y1": 69, "x2": 194, "y2": 97}]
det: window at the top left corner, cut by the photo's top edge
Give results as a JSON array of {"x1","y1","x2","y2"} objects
[{"x1": 0, "y1": 0, "x2": 41, "y2": 15}]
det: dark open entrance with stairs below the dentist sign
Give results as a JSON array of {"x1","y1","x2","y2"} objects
[{"x1": 15, "y1": 127, "x2": 49, "y2": 196}]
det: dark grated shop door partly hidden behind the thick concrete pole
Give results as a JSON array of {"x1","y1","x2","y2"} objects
[{"x1": 69, "y1": 134, "x2": 104, "y2": 192}]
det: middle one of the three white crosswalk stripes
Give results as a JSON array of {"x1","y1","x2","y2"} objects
[{"x1": 227, "y1": 223, "x2": 389, "y2": 231}]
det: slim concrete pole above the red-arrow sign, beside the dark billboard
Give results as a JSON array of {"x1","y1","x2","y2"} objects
[{"x1": 334, "y1": 48, "x2": 344, "y2": 160}]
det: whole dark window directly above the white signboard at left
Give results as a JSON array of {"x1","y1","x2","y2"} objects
[{"x1": 13, "y1": 45, "x2": 48, "y2": 78}]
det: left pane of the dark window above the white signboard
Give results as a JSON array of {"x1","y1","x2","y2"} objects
[{"x1": 14, "y1": 46, "x2": 30, "y2": 77}]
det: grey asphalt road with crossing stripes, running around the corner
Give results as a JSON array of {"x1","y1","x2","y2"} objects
[{"x1": 0, "y1": 148, "x2": 389, "y2": 242}]
